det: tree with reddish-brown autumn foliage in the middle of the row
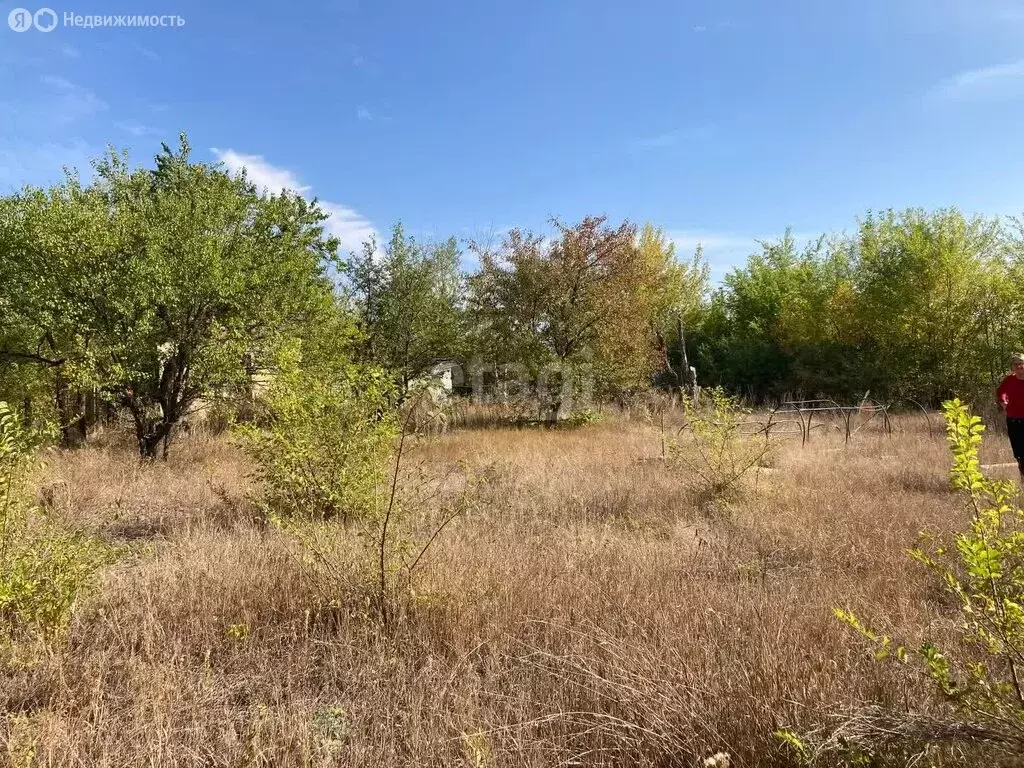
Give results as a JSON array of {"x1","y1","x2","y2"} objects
[{"x1": 470, "y1": 217, "x2": 653, "y2": 414}]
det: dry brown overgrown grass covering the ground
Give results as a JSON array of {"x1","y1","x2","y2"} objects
[{"x1": 0, "y1": 417, "x2": 1009, "y2": 768}]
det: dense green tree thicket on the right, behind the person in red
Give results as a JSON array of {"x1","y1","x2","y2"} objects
[{"x1": 693, "y1": 209, "x2": 1024, "y2": 406}]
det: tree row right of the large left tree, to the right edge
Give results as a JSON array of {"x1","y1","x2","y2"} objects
[{"x1": 305, "y1": 204, "x2": 1024, "y2": 407}]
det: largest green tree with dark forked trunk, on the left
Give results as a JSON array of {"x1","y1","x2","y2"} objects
[{"x1": 2, "y1": 135, "x2": 337, "y2": 458}]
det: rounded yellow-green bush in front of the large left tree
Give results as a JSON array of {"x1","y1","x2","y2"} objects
[{"x1": 237, "y1": 349, "x2": 396, "y2": 521}]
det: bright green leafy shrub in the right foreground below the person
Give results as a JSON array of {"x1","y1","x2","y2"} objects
[{"x1": 779, "y1": 399, "x2": 1024, "y2": 766}]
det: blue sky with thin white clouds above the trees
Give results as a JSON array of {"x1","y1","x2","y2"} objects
[{"x1": 0, "y1": 0, "x2": 1024, "y2": 275}]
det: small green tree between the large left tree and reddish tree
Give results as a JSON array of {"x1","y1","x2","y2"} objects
[{"x1": 345, "y1": 224, "x2": 464, "y2": 397}]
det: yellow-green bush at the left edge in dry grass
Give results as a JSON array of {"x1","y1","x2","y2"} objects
[{"x1": 0, "y1": 401, "x2": 112, "y2": 639}]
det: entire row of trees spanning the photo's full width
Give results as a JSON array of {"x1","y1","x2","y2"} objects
[{"x1": 0, "y1": 136, "x2": 1024, "y2": 456}]
